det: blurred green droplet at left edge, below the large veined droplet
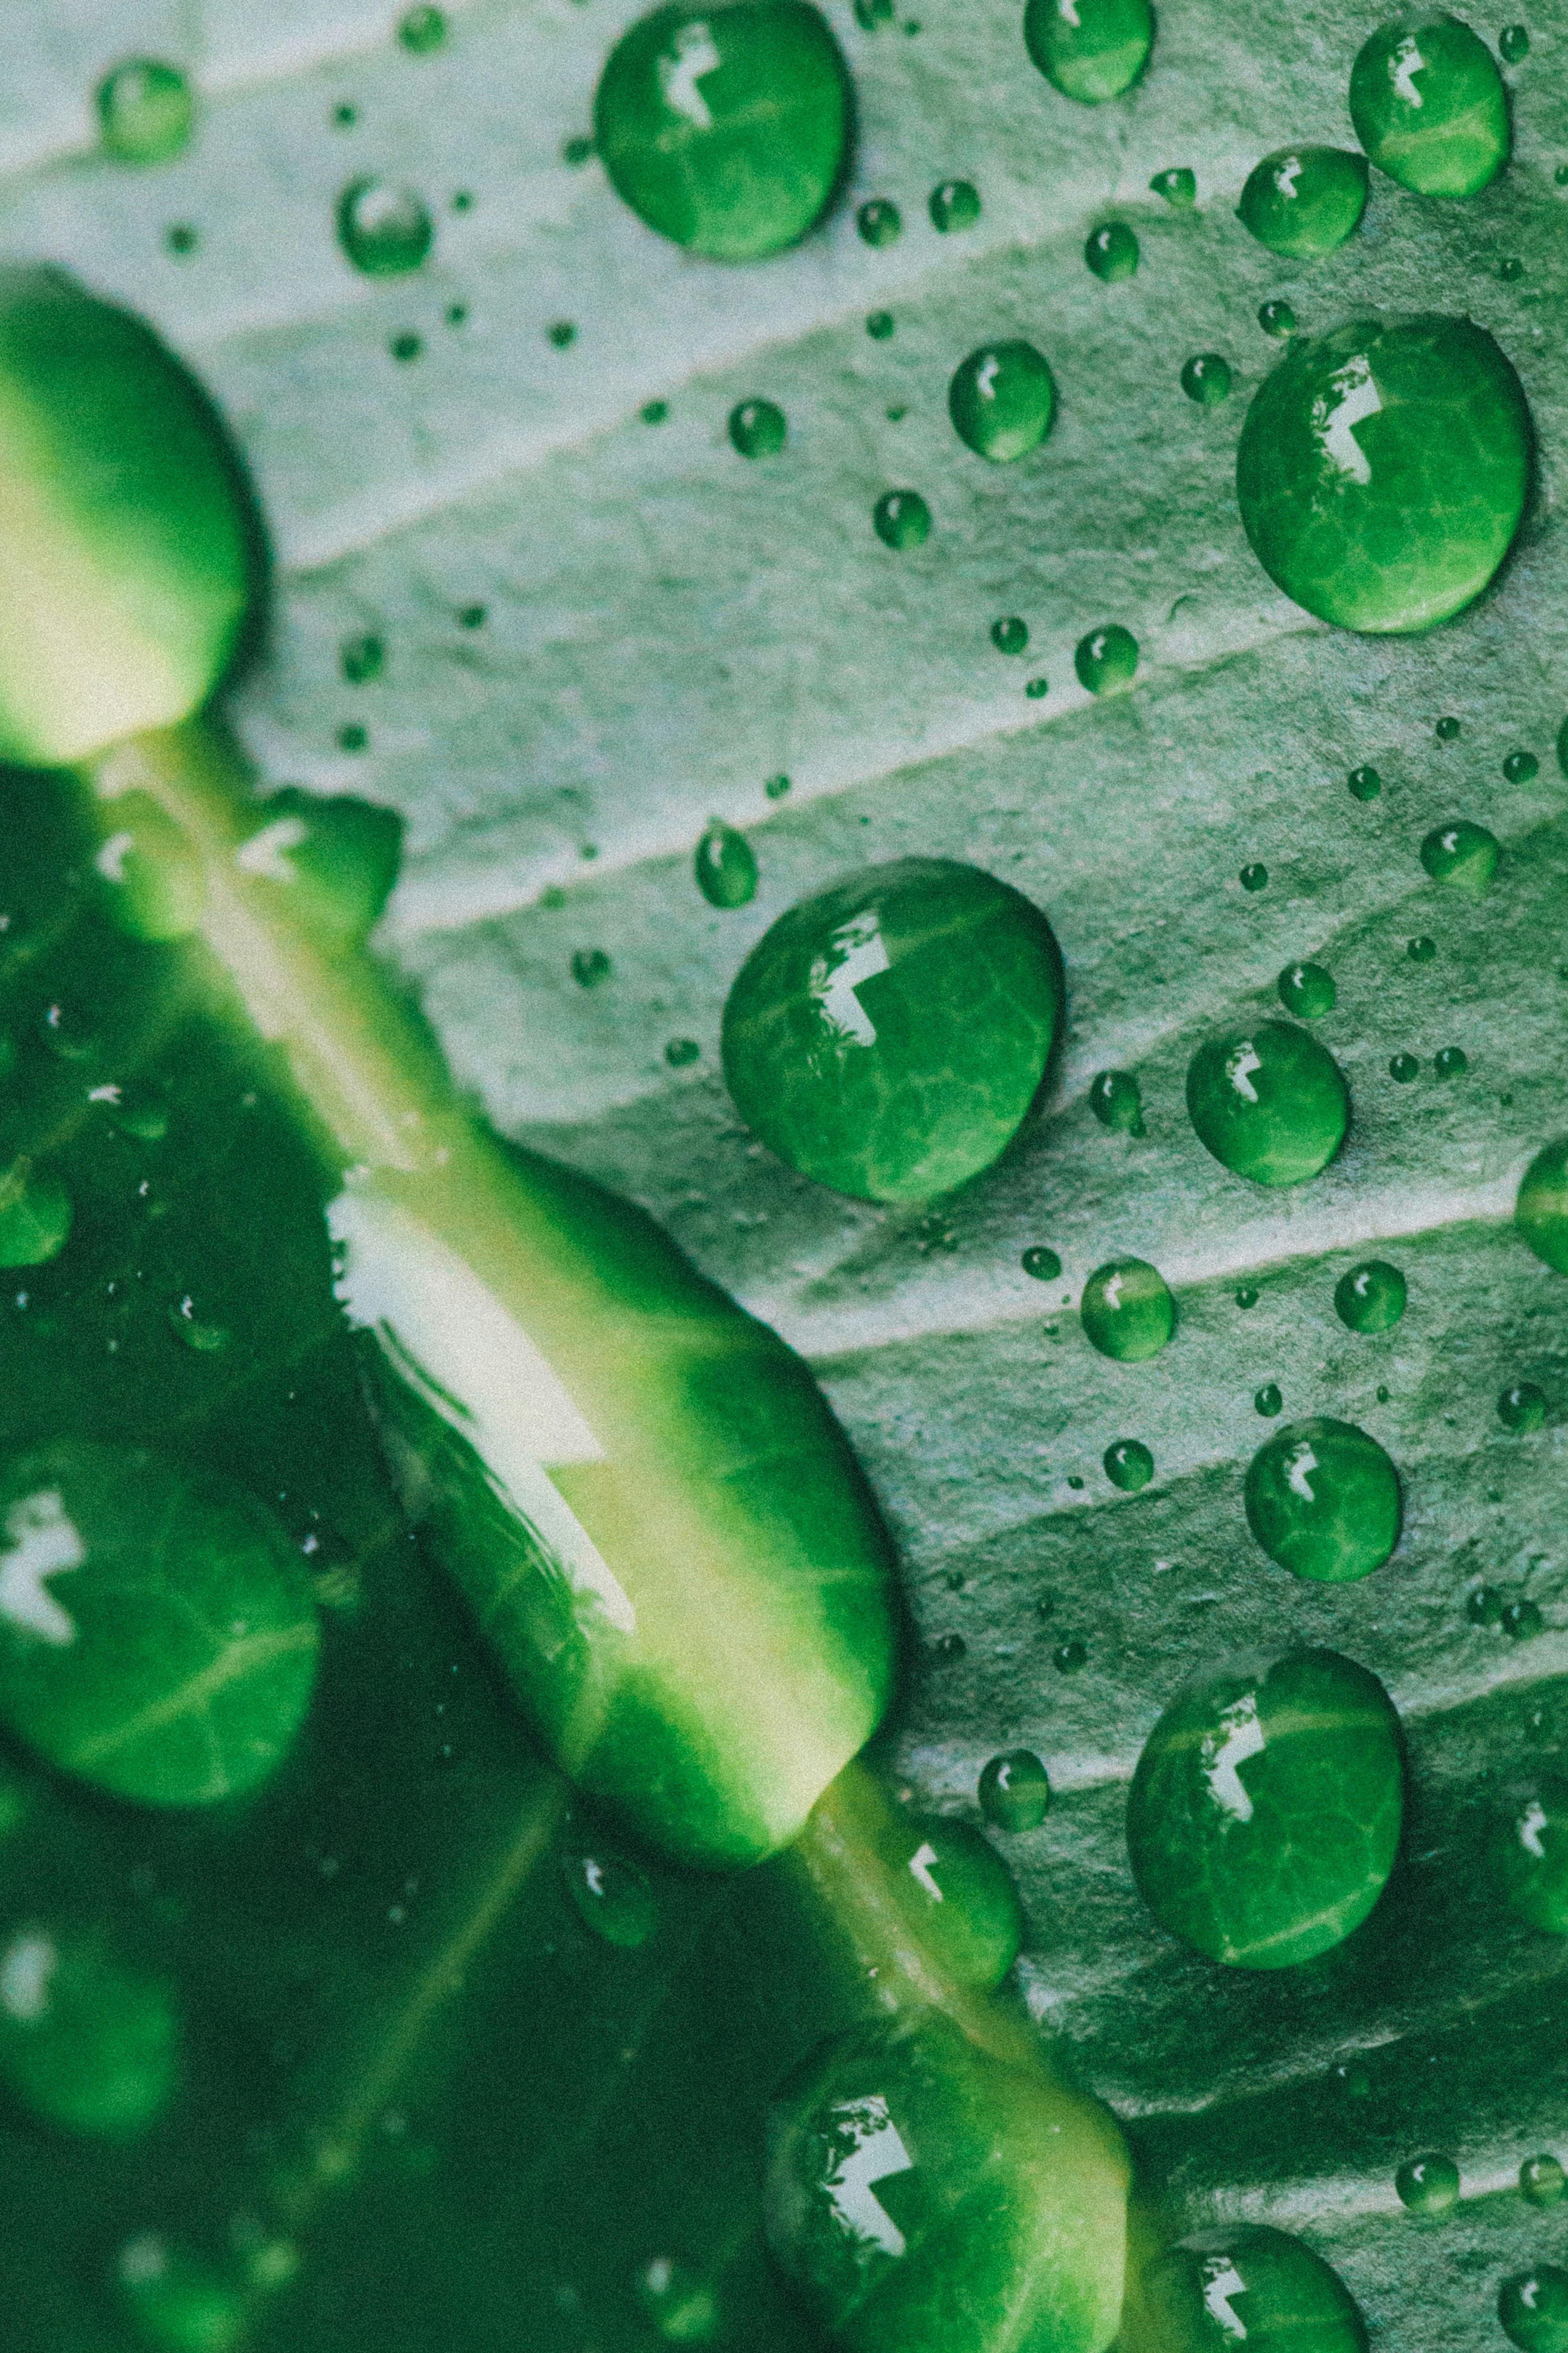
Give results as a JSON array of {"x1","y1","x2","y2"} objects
[{"x1": 0, "y1": 1923, "x2": 179, "y2": 2139}]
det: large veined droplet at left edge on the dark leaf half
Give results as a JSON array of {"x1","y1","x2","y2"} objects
[{"x1": 0, "y1": 1442, "x2": 320, "y2": 1805}]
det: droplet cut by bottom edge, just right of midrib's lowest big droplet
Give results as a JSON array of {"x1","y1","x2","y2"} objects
[{"x1": 1147, "y1": 2221, "x2": 1366, "y2": 2353}]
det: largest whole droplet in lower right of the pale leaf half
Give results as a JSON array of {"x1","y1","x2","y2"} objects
[{"x1": 1126, "y1": 1649, "x2": 1403, "y2": 1969}]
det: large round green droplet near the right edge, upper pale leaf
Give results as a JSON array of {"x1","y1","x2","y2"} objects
[{"x1": 1236, "y1": 313, "x2": 1530, "y2": 633}]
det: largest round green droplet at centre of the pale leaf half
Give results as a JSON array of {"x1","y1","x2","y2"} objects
[{"x1": 724, "y1": 859, "x2": 1062, "y2": 1200}]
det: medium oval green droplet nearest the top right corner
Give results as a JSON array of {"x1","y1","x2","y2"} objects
[{"x1": 1350, "y1": 9, "x2": 1509, "y2": 195}]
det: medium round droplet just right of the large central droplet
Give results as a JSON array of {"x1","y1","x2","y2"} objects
[{"x1": 1187, "y1": 1021, "x2": 1350, "y2": 1186}]
